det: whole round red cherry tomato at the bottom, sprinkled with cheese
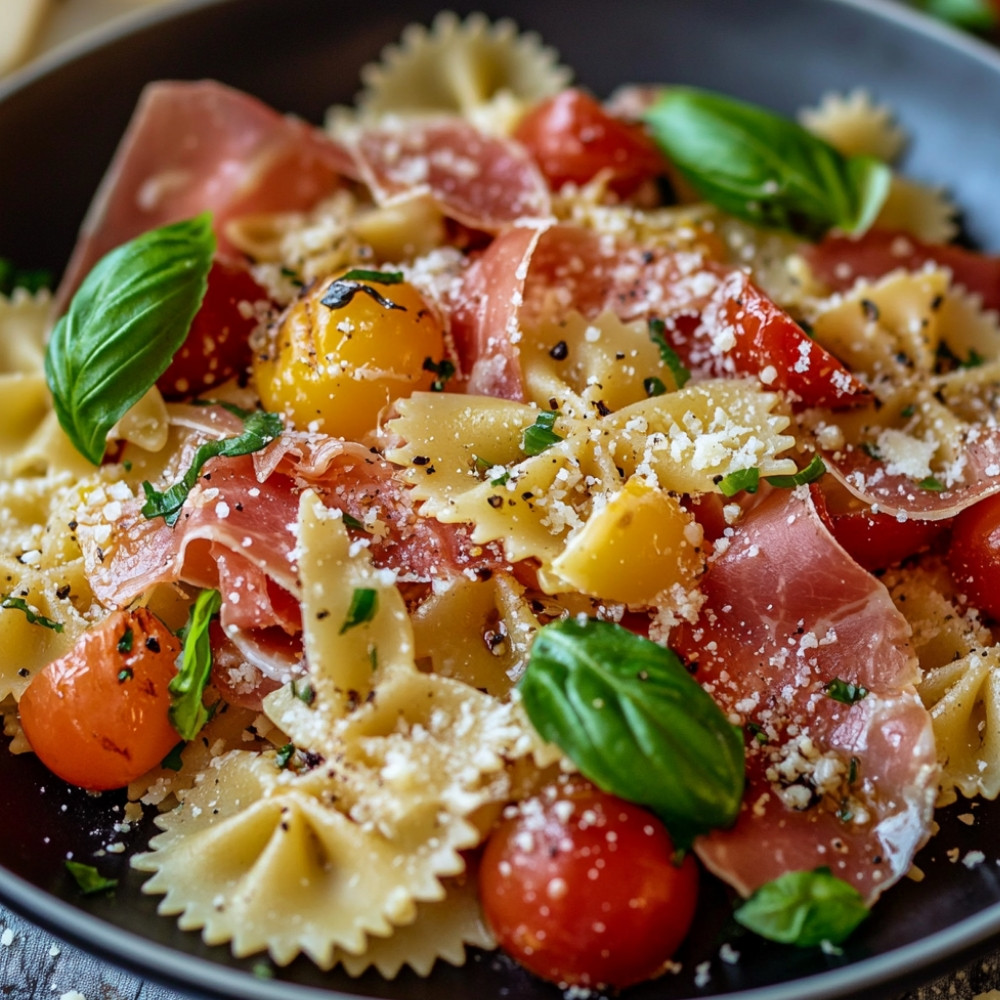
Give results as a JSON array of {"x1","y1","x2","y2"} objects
[{"x1": 479, "y1": 782, "x2": 698, "y2": 988}]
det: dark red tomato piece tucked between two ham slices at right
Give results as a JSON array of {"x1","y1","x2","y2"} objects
[{"x1": 812, "y1": 484, "x2": 950, "y2": 571}]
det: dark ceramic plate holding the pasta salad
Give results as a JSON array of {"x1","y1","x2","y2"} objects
[{"x1": 0, "y1": 0, "x2": 1000, "y2": 1000}]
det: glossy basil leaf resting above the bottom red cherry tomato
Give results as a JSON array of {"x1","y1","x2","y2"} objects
[{"x1": 520, "y1": 619, "x2": 744, "y2": 849}]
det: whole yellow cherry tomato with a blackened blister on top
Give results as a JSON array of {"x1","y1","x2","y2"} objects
[{"x1": 253, "y1": 272, "x2": 444, "y2": 440}]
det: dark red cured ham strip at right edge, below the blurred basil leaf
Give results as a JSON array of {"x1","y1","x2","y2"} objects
[{"x1": 802, "y1": 229, "x2": 1000, "y2": 311}]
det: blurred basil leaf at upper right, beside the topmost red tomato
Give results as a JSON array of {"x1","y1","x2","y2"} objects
[{"x1": 645, "y1": 87, "x2": 892, "y2": 238}]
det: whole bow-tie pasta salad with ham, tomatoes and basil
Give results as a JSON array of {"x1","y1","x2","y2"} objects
[{"x1": 0, "y1": 9, "x2": 1000, "y2": 989}]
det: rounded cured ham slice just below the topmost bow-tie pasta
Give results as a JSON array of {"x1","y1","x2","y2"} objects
[{"x1": 346, "y1": 118, "x2": 551, "y2": 232}]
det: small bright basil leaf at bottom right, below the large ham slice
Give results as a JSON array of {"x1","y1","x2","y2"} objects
[{"x1": 733, "y1": 868, "x2": 868, "y2": 948}]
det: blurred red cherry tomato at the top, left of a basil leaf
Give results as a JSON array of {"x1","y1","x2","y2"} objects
[{"x1": 514, "y1": 89, "x2": 666, "y2": 198}]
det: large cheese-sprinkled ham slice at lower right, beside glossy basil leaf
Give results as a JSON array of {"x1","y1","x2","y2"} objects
[{"x1": 671, "y1": 489, "x2": 937, "y2": 902}]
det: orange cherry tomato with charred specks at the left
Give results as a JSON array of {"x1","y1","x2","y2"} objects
[{"x1": 18, "y1": 608, "x2": 181, "y2": 791}]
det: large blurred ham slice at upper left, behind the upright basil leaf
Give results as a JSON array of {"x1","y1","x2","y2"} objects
[{"x1": 58, "y1": 80, "x2": 351, "y2": 306}]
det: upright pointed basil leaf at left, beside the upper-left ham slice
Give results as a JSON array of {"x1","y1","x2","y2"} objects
[{"x1": 45, "y1": 213, "x2": 215, "y2": 465}]
